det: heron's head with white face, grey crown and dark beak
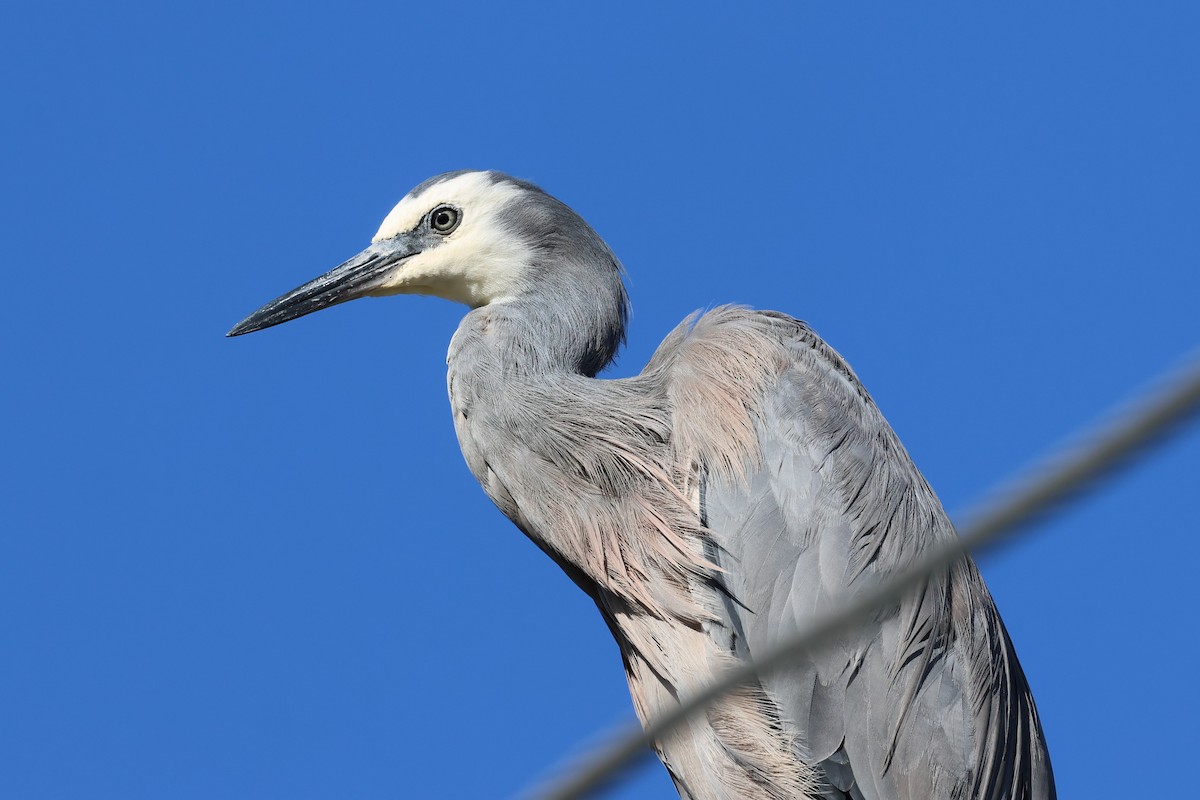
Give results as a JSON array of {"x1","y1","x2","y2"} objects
[{"x1": 228, "y1": 170, "x2": 625, "y2": 336}]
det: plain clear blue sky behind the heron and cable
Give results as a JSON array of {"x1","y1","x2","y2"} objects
[{"x1": 0, "y1": 1, "x2": 1200, "y2": 800}]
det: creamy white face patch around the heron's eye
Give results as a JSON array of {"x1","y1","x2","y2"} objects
[{"x1": 371, "y1": 173, "x2": 529, "y2": 308}]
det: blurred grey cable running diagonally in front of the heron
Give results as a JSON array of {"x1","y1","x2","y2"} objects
[{"x1": 528, "y1": 354, "x2": 1200, "y2": 800}]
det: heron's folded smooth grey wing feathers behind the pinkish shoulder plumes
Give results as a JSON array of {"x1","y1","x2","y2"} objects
[{"x1": 703, "y1": 311, "x2": 1054, "y2": 800}]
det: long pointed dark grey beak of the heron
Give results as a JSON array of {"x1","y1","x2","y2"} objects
[{"x1": 226, "y1": 236, "x2": 420, "y2": 336}]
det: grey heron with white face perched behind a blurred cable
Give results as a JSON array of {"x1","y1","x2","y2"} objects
[{"x1": 228, "y1": 170, "x2": 1055, "y2": 800}]
